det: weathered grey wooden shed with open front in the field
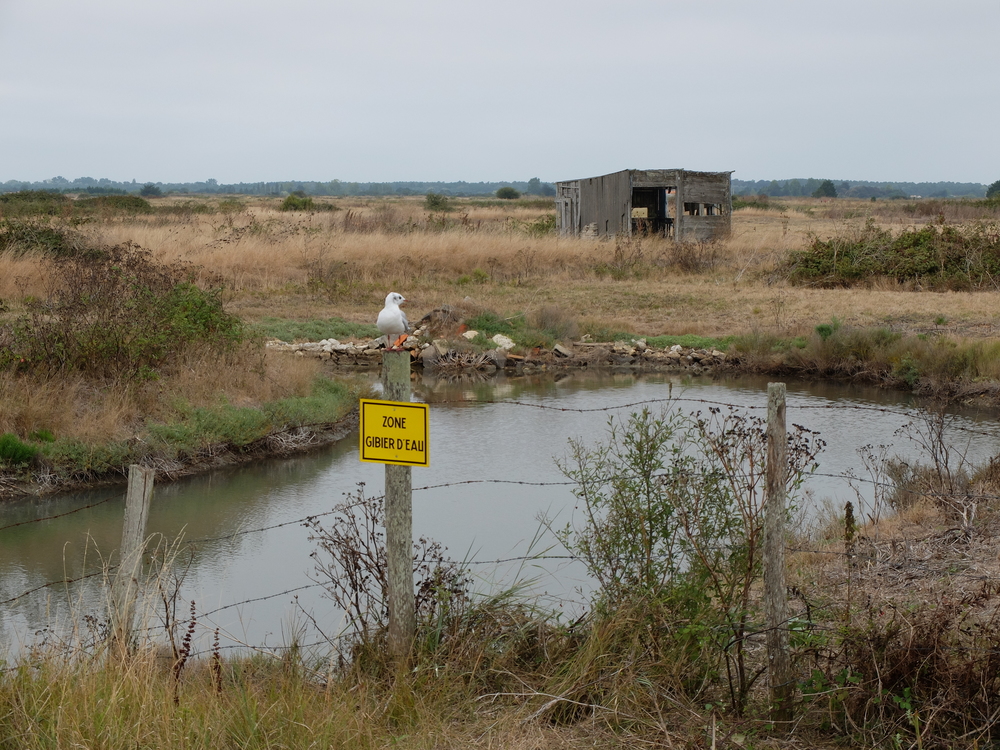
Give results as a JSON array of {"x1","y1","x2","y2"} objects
[{"x1": 556, "y1": 169, "x2": 733, "y2": 242}]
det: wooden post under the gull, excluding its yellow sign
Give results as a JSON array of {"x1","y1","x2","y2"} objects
[{"x1": 382, "y1": 350, "x2": 417, "y2": 663}]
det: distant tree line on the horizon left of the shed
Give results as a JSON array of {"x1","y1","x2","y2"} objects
[{"x1": 0, "y1": 177, "x2": 556, "y2": 197}]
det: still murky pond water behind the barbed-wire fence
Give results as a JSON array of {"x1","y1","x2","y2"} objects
[{"x1": 0, "y1": 374, "x2": 1000, "y2": 651}]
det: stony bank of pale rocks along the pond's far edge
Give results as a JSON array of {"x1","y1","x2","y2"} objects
[{"x1": 267, "y1": 329, "x2": 732, "y2": 374}]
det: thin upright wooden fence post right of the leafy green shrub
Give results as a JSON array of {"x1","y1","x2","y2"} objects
[{"x1": 764, "y1": 383, "x2": 792, "y2": 723}]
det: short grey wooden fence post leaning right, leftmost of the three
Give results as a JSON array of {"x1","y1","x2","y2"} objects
[{"x1": 110, "y1": 464, "x2": 155, "y2": 650}]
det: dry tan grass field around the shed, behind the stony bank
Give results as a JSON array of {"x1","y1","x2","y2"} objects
[{"x1": 7, "y1": 196, "x2": 1000, "y2": 344}]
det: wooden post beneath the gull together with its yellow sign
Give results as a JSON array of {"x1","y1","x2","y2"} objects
[{"x1": 360, "y1": 349, "x2": 429, "y2": 663}]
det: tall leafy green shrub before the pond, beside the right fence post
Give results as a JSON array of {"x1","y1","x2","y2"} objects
[{"x1": 548, "y1": 408, "x2": 824, "y2": 714}]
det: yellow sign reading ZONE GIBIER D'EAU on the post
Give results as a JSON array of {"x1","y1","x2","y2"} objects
[{"x1": 360, "y1": 398, "x2": 430, "y2": 466}]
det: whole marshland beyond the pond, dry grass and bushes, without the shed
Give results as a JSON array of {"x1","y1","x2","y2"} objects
[{"x1": 0, "y1": 191, "x2": 1000, "y2": 486}]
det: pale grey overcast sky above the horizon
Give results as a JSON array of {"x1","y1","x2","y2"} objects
[{"x1": 0, "y1": 0, "x2": 1000, "y2": 183}]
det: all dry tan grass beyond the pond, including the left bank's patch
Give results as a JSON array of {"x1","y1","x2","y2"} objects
[{"x1": 0, "y1": 196, "x2": 1000, "y2": 476}]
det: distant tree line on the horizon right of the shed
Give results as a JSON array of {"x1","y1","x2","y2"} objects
[{"x1": 733, "y1": 177, "x2": 986, "y2": 199}]
